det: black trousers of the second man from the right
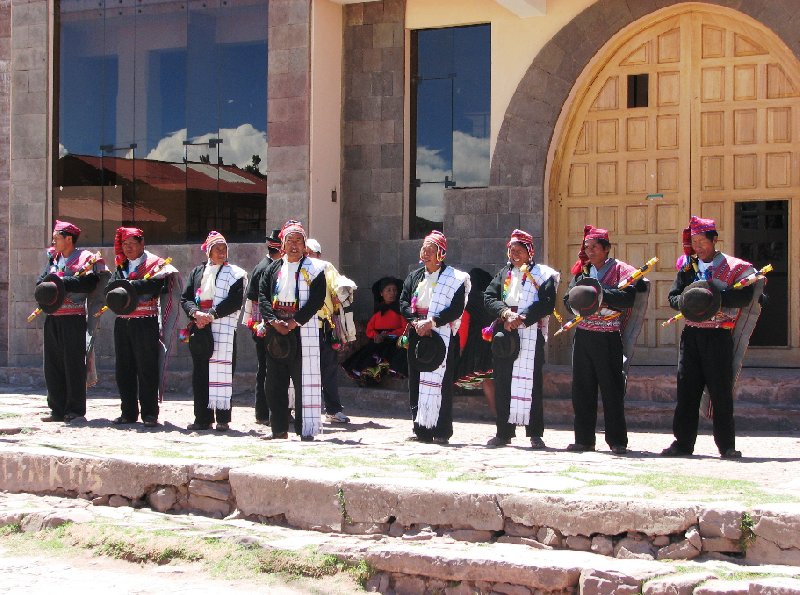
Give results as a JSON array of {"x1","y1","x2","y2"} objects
[{"x1": 572, "y1": 328, "x2": 628, "y2": 446}]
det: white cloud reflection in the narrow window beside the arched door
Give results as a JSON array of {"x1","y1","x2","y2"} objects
[{"x1": 416, "y1": 130, "x2": 489, "y2": 221}]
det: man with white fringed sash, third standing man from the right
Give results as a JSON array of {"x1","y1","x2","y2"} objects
[{"x1": 484, "y1": 229, "x2": 559, "y2": 450}]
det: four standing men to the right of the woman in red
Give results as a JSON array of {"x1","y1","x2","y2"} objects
[{"x1": 400, "y1": 216, "x2": 756, "y2": 459}]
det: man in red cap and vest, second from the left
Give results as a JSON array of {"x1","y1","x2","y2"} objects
[{"x1": 105, "y1": 227, "x2": 180, "y2": 427}]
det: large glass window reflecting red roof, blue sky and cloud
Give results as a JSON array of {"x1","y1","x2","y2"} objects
[{"x1": 53, "y1": 0, "x2": 268, "y2": 245}]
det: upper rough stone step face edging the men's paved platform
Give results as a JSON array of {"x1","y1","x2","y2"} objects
[{"x1": 0, "y1": 452, "x2": 800, "y2": 566}]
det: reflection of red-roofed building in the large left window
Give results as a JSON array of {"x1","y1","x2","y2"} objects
[{"x1": 53, "y1": 155, "x2": 267, "y2": 244}]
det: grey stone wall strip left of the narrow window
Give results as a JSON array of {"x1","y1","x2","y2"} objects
[{"x1": 341, "y1": 0, "x2": 410, "y2": 318}]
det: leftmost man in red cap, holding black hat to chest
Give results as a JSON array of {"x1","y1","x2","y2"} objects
[{"x1": 35, "y1": 221, "x2": 108, "y2": 423}]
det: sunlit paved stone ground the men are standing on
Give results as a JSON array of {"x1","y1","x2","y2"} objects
[{"x1": 0, "y1": 386, "x2": 800, "y2": 505}]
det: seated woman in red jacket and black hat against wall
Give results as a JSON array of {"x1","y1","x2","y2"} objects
[{"x1": 342, "y1": 277, "x2": 408, "y2": 384}]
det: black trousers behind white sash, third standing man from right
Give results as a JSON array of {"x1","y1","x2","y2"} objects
[{"x1": 492, "y1": 330, "x2": 544, "y2": 440}]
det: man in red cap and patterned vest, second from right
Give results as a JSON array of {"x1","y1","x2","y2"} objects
[{"x1": 564, "y1": 225, "x2": 646, "y2": 455}]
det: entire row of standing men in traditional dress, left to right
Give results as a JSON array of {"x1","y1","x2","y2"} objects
[{"x1": 35, "y1": 217, "x2": 754, "y2": 458}]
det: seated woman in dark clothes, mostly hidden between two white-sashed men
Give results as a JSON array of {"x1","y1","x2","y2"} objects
[{"x1": 456, "y1": 268, "x2": 494, "y2": 412}]
